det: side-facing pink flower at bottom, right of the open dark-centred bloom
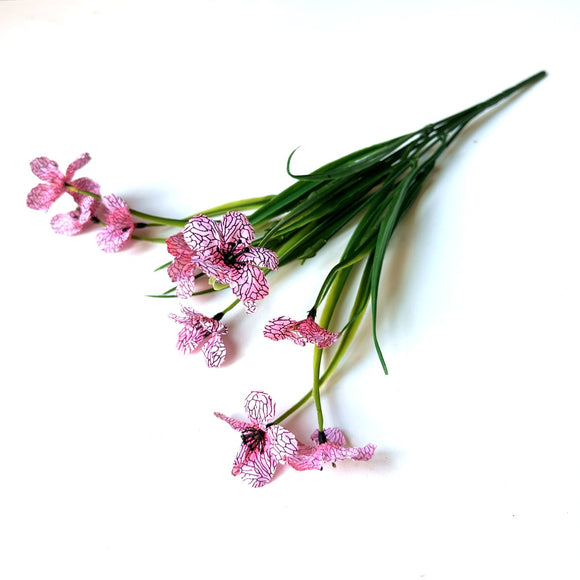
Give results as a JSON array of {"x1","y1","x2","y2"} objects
[{"x1": 288, "y1": 427, "x2": 376, "y2": 471}]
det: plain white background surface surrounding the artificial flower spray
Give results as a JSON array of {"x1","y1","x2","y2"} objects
[{"x1": 0, "y1": 0, "x2": 580, "y2": 580}]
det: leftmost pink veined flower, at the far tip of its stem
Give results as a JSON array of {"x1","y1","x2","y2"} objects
[{"x1": 26, "y1": 153, "x2": 100, "y2": 236}]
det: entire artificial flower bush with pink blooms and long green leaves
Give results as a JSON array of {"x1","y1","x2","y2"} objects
[{"x1": 27, "y1": 72, "x2": 546, "y2": 487}]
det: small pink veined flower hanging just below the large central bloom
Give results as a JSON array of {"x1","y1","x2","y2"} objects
[{"x1": 169, "y1": 306, "x2": 228, "y2": 367}]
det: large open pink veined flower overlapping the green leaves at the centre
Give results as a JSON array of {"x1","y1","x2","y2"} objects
[{"x1": 183, "y1": 211, "x2": 278, "y2": 312}]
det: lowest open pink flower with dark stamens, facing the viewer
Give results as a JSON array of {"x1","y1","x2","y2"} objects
[{"x1": 215, "y1": 391, "x2": 298, "y2": 487}]
